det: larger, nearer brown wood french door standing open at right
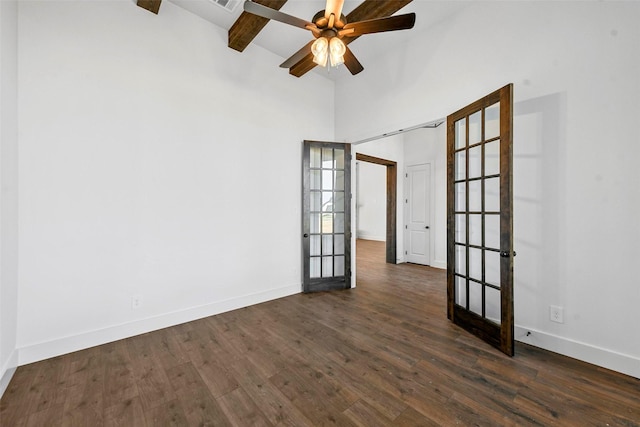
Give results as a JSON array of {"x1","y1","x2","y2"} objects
[{"x1": 447, "y1": 84, "x2": 515, "y2": 356}]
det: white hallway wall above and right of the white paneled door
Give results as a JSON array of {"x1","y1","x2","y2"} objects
[{"x1": 403, "y1": 123, "x2": 447, "y2": 268}]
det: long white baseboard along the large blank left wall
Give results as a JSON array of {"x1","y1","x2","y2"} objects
[{"x1": 18, "y1": 284, "x2": 302, "y2": 365}]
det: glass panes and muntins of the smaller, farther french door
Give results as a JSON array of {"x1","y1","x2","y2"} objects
[{"x1": 309, "y1": 145, "x2": 348, "y2": 279}]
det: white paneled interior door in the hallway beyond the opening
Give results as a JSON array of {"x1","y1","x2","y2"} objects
[{"x1": 405, "y1": 164, "x2": 431, "y2": 265}]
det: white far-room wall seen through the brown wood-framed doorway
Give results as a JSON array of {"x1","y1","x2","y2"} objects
[{"x1": 356, "y1": 162, "x2": 387, "y2": 242}]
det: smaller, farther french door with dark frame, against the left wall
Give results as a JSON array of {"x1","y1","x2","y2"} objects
[{"x1": 302, "y1": 141, "x2": 351, "y2": 292}]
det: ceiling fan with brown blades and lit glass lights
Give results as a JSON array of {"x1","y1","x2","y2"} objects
[{"x1": 244, "y1": 0, "x2": 416, "y2": 75}]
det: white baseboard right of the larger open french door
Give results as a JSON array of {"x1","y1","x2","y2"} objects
[{"x1": 515, "y1": 326, "x2": 640, "y2": 378}]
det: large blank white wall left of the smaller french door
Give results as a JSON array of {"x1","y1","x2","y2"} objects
[{"x1": 18, "y1": 1, "x2": 334, "y2": 363}]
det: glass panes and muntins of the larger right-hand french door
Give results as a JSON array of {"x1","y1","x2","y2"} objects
[{"x1": 454, "y1": 102, "x2": 501, "y2": 324}]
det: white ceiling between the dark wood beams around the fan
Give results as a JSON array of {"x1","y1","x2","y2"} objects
[{"x1": 169, "y1": 0, "x2": 466, "y2": 79}]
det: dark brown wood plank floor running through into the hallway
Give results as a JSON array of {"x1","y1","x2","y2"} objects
[{"x1": 0, "y1": 241, "x2": 640, "y2": 427}]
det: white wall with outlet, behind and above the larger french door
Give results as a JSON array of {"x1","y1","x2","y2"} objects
[{"x1": 336, "y1": 2, "x2": 640, "y2": 377}]
